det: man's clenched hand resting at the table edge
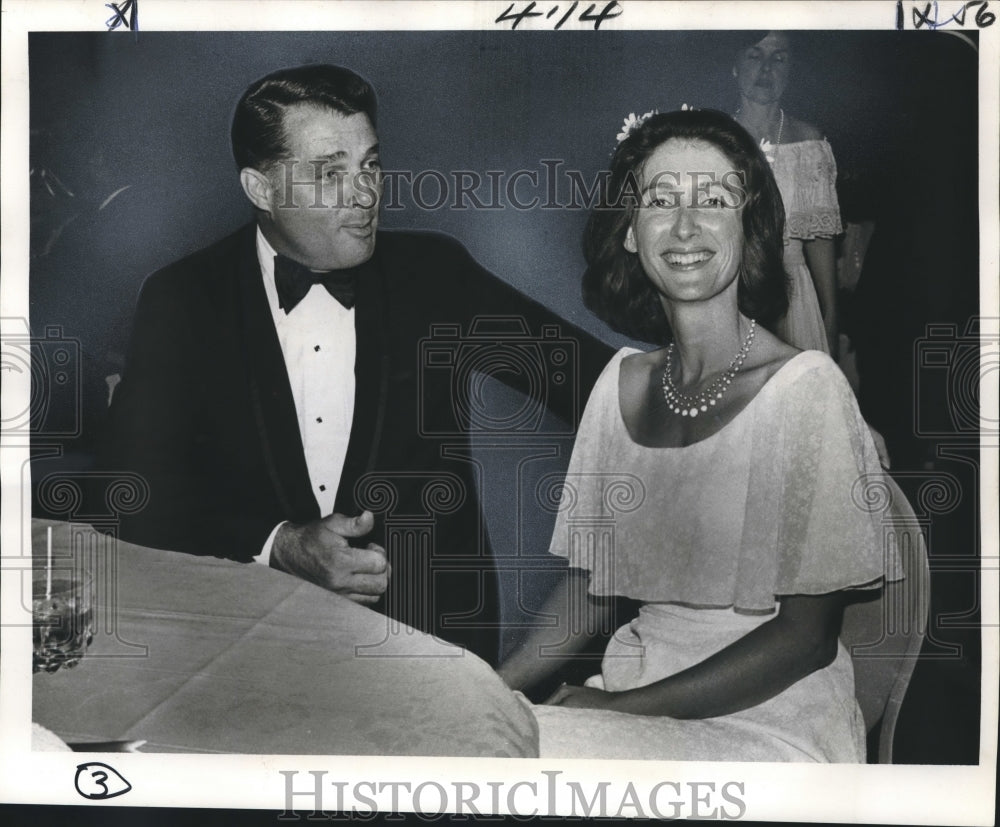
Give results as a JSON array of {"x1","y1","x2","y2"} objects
[{"x1": 271, "y1": 511, "x2": 390, "y2": 604}]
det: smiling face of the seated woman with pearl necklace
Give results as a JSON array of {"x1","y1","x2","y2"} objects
[{"x1": 625, "y1": 138, "x2": 743, "y2": 312}]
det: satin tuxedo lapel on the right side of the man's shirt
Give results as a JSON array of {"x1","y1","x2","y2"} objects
[{"x1": 336, "y1": 249, "x2": 391, "y2": 515}]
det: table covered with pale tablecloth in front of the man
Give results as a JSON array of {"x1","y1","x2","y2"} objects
[{"x1": 32, "y1": 520, "x2": 537, "y2": 757}]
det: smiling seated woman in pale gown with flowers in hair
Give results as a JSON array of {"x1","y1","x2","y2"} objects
[{"x1": 500, "y1": 110, "x2": 905, "y2": 762}]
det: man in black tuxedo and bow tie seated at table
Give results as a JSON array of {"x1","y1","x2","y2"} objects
[{"x1": 103, "y1": 65, "x2": 610, "y2": 662}]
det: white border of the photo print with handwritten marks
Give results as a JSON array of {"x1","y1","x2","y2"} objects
[{"x1": 0, "y1": 0, "x2": 1000, "y2": 825}]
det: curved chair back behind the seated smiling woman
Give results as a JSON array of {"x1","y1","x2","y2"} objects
[{"x1": 840, "y1": 477, "x2": 930, "y2": 764}]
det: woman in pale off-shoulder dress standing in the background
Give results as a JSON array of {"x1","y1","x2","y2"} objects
[{"x1": 733, "y1": 32, "x2": 842, "y2": 359}]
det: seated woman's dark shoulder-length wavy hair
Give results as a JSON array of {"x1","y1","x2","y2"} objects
[{"x1": 583, "y1": 109, "x2": 788, "y2": 344}]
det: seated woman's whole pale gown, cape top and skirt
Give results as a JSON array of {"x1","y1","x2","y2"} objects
[{"x1": 533, "y1": 348, "x2": 908, "y2": 762}]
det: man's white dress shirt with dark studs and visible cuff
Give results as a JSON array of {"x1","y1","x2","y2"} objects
[{"x1": 254, "y1": 227, "x2": 357, "y2": 564}]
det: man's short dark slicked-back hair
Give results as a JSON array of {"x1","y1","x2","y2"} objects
[{"x1": 230, "y1": 63, "x2": 377, "y2": 169}]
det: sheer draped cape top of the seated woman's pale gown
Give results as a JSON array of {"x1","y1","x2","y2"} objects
[{"x1": 550, "y1": 349, "x2": 912, "y2": 613}]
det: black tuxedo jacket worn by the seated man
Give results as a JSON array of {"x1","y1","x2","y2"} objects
[{"x1": 102, "y1": 225, "x2": 611, "y2": 662}]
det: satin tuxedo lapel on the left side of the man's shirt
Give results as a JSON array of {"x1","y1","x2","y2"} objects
[{"x1": 237, "y1": 230, "x2": 320, "y2": 521}]
